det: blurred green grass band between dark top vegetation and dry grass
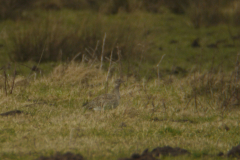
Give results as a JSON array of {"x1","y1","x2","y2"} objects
[{"x1": 0, "y1": 10, "x2": 240, "y2": 77}]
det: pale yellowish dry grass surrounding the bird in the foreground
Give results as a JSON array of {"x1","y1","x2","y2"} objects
[{"x1": 0, "y1": 64, "x2": 240, "y2": 159}]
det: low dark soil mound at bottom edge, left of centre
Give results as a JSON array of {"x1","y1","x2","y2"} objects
[{"x1": 36, "y1": 152, "x2": 84, "y2": 160}]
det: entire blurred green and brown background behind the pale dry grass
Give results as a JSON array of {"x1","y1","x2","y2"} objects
[{"x1": 0, "y1": 0, "x2": 240, "y2": 75}]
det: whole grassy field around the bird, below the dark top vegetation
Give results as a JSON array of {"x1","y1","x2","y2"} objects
[{"x1": 0, "y1": 5, "x2": 240, "y2": 160}]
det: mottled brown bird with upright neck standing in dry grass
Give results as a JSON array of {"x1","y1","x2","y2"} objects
[{"x1": 83, "y1": 79, "x2": 124, "y2": 111}]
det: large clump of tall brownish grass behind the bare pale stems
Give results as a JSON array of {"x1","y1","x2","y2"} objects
[{"x1": 6, "y1": 13, "x2": 143, "y2": 62}]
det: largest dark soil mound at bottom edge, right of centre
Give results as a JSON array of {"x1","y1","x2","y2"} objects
[{"x1": 119, "y1": 146, "x2": 190, "y2": 160}]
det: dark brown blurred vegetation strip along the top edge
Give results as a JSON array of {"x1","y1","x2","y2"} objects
[{"x1": 0, "y1": 0, "x2": 240, "y2": 23}]
